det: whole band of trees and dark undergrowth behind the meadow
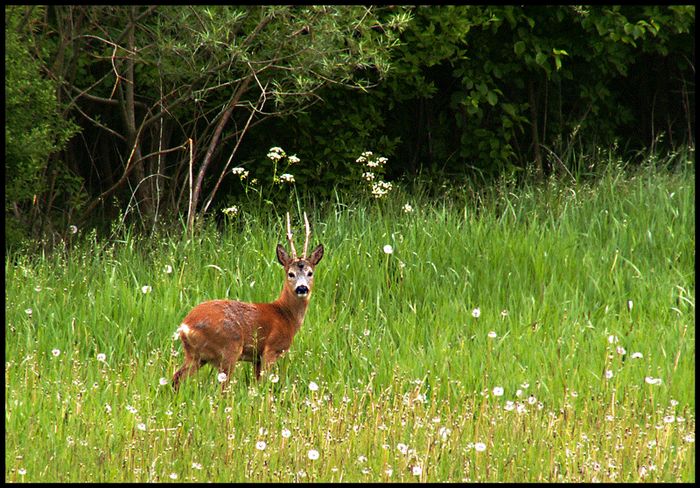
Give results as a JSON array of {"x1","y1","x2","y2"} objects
[{"x1": 5, "y1": 5, "x2": 695, "y2": 247}]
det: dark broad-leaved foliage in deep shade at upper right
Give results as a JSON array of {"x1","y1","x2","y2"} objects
[{"x1": 270, "y1": 5, "x2": 695, "y2": 179}]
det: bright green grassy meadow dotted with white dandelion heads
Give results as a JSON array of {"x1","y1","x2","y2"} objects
[{"x1": 5, "y1": 158, "x2": 696, "y2": 482}]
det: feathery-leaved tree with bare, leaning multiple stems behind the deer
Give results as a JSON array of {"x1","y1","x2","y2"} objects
[{"x1": 27, "y1": 6, "x2": 407, "y2": 231}]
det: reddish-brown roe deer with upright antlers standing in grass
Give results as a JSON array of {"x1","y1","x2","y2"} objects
[{"x1": 172, "y1": 212, "x2": 323, "y2": 390}]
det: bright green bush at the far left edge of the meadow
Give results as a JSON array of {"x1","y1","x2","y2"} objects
[{"x1": 5, "y1": 7, "x2": 80, "y2": 247}]
